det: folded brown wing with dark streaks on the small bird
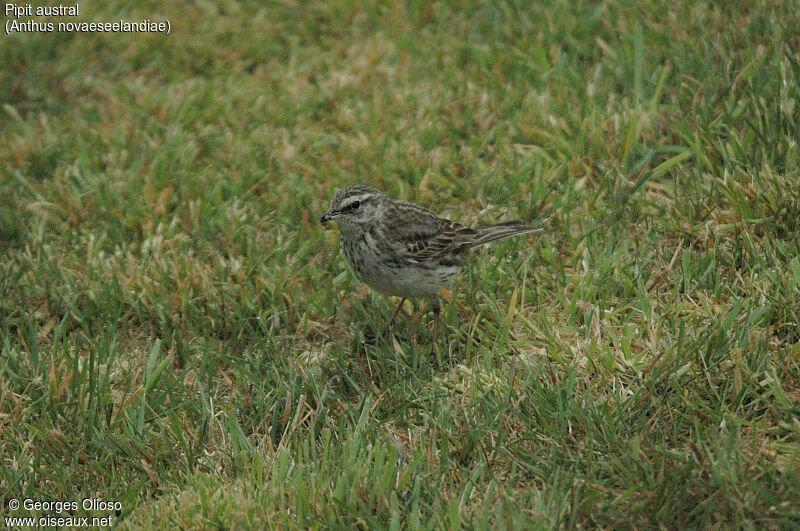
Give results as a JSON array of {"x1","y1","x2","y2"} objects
[{"x1": 387, "y1": 203, "x2": 476, "y2": 263}]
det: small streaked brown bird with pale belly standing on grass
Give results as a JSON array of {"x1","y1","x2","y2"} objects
[{"x1": 319, "y1": 184, "x2": 542, "y2": 343}]
